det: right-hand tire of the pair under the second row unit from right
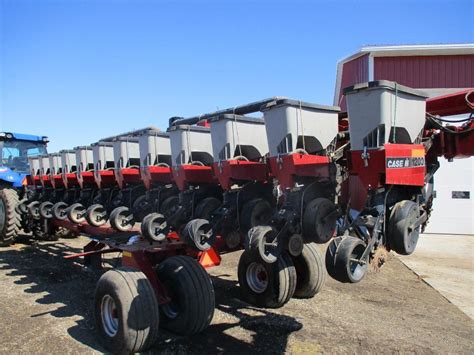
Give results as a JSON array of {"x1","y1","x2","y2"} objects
[{"x1": 291, "y1": 243, "x2": 326, "y2": 298}]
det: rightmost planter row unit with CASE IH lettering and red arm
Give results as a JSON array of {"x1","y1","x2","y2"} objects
[{"x1": 326, "y1": 81, "x2": 474, "y2": 282}]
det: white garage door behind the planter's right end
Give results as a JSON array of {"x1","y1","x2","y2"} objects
[{"x1": 426, "y1": 158, "x2": 474, "y2": 234}]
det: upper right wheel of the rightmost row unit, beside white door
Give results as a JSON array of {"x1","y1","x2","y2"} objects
[{"x1": 387, "y1": 200, "x2": 421, "y2": 255}]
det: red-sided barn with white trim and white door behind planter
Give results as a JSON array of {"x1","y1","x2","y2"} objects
[{"x1": 334, "y1": 43, "x2": 474, "y2": 234}]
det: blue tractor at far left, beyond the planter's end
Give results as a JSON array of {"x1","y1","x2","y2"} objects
[{"x1": 0, "y1": 132, "x2": 48, "y2": 246}]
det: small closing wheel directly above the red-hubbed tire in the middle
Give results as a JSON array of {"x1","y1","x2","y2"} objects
[{"x1": 245, "y1": 226, "x2": 282, "y2": 264}]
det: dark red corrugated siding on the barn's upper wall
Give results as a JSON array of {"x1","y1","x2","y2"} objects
[{"x1": 374, "y1": 55, "x2": 474, "y2": 89}]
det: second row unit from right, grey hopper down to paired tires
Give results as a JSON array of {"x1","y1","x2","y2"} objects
[{"x1": 230, "y1": 99, "x2": 339, "y2": 306}]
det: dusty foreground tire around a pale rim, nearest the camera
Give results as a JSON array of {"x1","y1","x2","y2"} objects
[{"x1": 94, "y1": 267, "x2": 159, "y2": 354}]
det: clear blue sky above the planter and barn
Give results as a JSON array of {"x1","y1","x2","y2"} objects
[{"x1": 0, "y1": 0, "x2": 474, "y2": 151}]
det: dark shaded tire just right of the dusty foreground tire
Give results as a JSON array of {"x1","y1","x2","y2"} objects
[{"x1": 157, "y1": 256, "x2": 215, "y2": 335}]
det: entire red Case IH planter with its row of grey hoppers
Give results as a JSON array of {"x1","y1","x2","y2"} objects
[{"x1": 0, "y1": 82, "x2": 474, "y2": 353}]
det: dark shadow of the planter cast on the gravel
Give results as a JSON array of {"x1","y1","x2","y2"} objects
[{"x1": 0, "y1": 236, "x2": 302, "y2": 353}]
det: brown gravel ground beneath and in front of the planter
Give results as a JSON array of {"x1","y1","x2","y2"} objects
[{"x1": 0, "y1": 238, "x2": 474, "y2": 354}]
